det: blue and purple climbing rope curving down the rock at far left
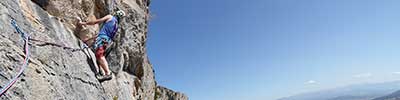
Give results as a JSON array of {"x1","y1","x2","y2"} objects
[{"x1": 0, "y1": 20, "x2": 30, "y2": 96}]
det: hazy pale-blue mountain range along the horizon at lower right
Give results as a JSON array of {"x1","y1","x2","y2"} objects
[{"x1": 277, "y1": 81, "x2": 400, "y2": 100}]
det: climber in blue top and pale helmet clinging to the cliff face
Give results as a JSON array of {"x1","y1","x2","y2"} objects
[{"x1": 79, "y1": 10, "x2": 125, "y2": 81}]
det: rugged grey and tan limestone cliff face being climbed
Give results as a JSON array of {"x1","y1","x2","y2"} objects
[{"x1": 0, "y1": 0, "x2": 188, "y2": 100}]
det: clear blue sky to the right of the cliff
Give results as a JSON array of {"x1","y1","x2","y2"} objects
[{"x1": 147, "y1": 0, "x2": 400, "y2": 100}]
